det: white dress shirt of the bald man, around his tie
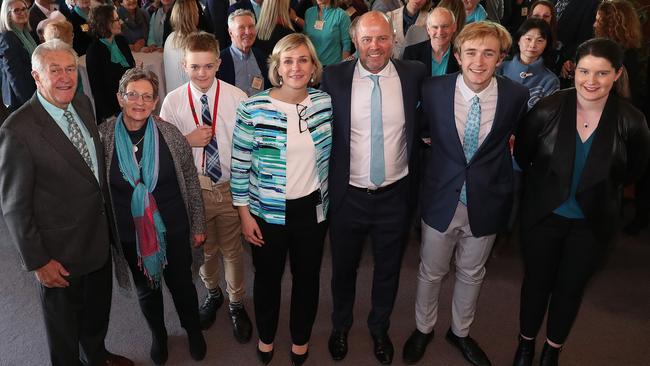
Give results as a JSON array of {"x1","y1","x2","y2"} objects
[{"x1": 350, "y1": 62, "x2": 408, "y2": 188}]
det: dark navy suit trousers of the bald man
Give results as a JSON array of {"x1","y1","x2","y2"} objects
[{"x1": 330, "y1": 178, "x2": 412, "y2": 334}]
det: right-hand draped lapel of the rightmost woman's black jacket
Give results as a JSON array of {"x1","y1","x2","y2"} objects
[{"x1": 577, "y1": 95, "x2": 618, "y2": 192}]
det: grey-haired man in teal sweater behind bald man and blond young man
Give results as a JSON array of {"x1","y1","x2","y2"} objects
[{"x1": 402, "y1": 7, "x2": 459, "y2": 76}]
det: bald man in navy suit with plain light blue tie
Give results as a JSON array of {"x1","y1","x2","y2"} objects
[{"x1": 322, "y1": 11, "x2": 426, "y2": 364}]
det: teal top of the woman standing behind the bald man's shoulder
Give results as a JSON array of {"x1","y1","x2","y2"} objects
[{"x1": 303, "y1": 6, "x2": 352, "y2": 66}]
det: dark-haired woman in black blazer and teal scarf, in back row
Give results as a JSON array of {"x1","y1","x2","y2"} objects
[{"x1": 86, "y1": 5, "x2": 135, "y2": 123}]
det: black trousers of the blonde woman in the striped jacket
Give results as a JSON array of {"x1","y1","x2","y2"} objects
[{"x1": 251, "y1": 191, "x2": 327, "y2": 345}]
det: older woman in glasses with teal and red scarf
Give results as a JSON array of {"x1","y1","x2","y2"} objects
[{"x1": 100, "y1": 68, "x2": 206, "y2": 365}]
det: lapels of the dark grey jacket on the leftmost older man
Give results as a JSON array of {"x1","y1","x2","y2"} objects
[{"x1": 29, "y1": 93, "x2": 98, "y2": 184}]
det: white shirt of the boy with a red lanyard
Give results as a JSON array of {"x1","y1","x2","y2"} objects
[{"x1": 160, "y1": 78, "x2": 247, "y2": 183}]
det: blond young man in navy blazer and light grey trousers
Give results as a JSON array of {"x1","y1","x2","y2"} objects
[{"x1": 403, "y1": 22, "x2": 528, "y2": 366}]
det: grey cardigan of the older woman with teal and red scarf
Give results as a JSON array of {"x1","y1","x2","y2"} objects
[{"x1": 99, "y1": 117, "x2": 206, "y2": 290}]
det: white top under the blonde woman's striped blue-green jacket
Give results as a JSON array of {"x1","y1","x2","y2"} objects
[{"x1": 270, "y1": 96, "x2": 319, "y2": 200}]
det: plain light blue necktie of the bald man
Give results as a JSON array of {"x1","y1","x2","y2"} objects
[{"x1": 368, "y1": 75, "x2": 386, "y2": 187}]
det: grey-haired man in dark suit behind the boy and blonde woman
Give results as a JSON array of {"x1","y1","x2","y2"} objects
[{"x1": 217, "y1": 9, "x2": 271, "y2": 97}]
